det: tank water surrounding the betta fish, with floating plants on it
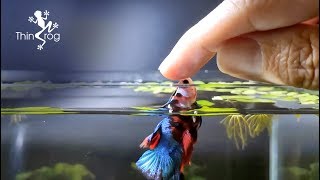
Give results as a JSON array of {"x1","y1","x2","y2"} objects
[{"x1": 1, "y1": 74, "x2": 319, "y2": 180}]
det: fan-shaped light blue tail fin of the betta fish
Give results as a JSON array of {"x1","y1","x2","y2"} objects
[{"x1": 136, "y1": 150, "x2": 175, "y2": 179}]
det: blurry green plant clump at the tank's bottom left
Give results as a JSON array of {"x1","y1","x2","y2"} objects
[{"x1": 16, "y1": 163, "x2": 95, "y2": 180}]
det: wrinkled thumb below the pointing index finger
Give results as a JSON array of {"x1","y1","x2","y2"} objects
[{"x1": 217, "y1": 24, "x2": 319, "y2": 89}]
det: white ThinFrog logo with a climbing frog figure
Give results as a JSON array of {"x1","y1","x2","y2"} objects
[{"x1": 16, "y1": 10, "x2": 60, "y2": 51}]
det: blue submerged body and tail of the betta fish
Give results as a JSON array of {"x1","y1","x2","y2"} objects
[{"x1": 136, "y1": 117, "x2": 183, "y2": 180}]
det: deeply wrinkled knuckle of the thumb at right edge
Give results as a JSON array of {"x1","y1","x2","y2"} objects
[{"x1": 266, "y1": 26, "x2": 319, "y2": 89}]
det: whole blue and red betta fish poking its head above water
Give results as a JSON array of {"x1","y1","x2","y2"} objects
[{"x1": 136, "y1": 78, "x2": 202, "y2": 180}]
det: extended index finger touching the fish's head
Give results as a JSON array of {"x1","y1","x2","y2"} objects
[{"x1": 159, "y1": 0, "x2": 319, "y2": 80}]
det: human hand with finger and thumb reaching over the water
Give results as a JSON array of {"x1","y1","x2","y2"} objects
[{"x1": 159, "y1": 0, "x2": 319, "y2": 90}]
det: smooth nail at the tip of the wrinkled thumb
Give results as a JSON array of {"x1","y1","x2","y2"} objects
[{"x1": 217, "y1": 38, "x2": 262, "y2": 80}]
